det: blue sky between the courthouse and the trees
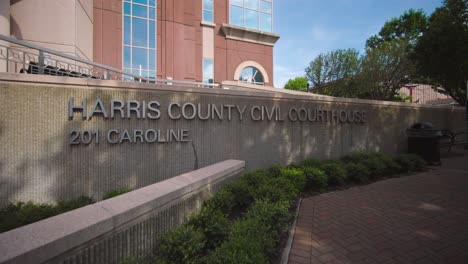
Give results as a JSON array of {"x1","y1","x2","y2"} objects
[{"x1": 273, "y1": 0, "x2": 442, "y2": 87}]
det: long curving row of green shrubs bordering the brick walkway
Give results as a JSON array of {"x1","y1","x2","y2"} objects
[{"x1": 155, "y1": 153, "x2": 425, "y2": 263}]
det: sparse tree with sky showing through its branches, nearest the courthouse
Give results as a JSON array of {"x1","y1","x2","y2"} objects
[{"x1": 306, "y1": 49, "x2": 361, "y2": 97}]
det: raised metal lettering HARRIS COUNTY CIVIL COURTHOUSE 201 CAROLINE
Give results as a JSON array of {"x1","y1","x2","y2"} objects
[{"x1": 68, "y1": 97, "x2": 367, "y2": 145}]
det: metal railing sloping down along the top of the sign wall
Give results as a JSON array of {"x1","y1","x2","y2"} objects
[{"x1": 0, "y1": 34, "x2": 219, "y2": 88}]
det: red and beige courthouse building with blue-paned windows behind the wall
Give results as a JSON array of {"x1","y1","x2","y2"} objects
[{"x1": 0, "y1": 0, "x2": 279, "y2": 86}]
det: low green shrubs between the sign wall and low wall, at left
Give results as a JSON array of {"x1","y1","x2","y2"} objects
[{"x1": 0, "y1": 188, "x2": 131, "y2": 233}]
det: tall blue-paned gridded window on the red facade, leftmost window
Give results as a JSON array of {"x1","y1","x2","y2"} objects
[{"x1": 123, "y1": 0, "x2": 156, "y2": 78}]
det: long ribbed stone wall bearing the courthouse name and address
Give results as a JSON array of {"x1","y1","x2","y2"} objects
[{"x1": 0, "y1": 75, "x2": 464, "y2": 204}]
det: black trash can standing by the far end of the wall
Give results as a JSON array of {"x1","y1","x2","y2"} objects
[{"x1": 406, "y1": 123, "x2": 442, "y2": 165}]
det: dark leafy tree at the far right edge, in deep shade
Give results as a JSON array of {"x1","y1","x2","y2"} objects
[{"x1": 414, "y1": 0, "x2": 468, "y2": 105}]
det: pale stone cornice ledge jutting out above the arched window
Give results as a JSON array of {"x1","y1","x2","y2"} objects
[{"x1": 221, "y1": 24, "x2": 280, "y2": 46}]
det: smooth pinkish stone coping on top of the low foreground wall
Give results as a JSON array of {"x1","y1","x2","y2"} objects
[{"x1": 0, "y1": 160, "x2": 245, "y2": 263}]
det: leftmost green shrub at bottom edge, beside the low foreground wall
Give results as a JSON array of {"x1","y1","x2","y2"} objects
[{"x1": 156, "y1": 225, "x2": 206, "y2": 264}]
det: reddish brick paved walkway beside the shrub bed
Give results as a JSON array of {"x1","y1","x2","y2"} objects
[{"x1": 289, "y1": 153, "x2": 468, "y2": 264}]
